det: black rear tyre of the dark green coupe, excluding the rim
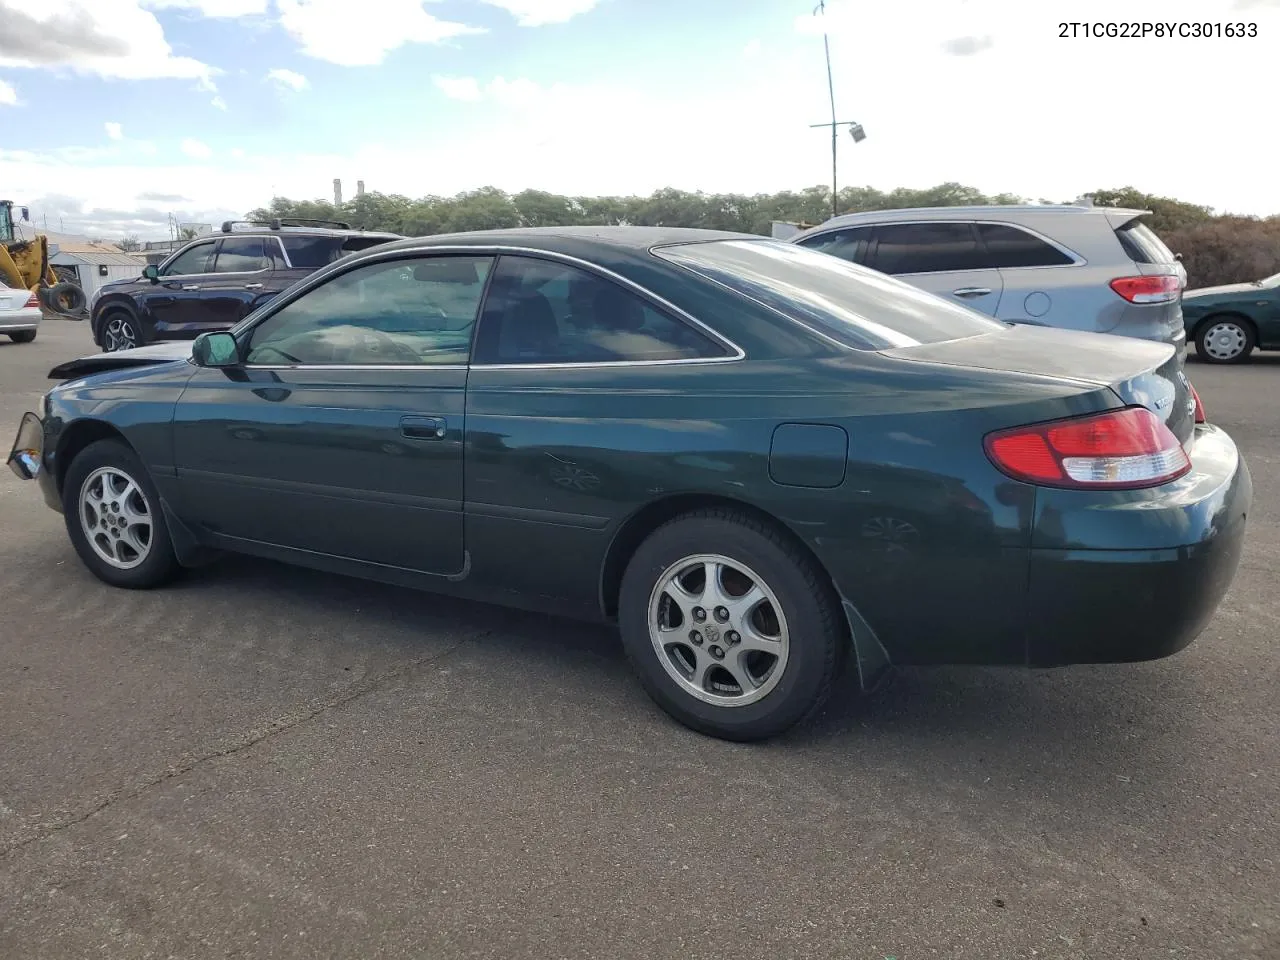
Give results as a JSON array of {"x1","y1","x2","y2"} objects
[{"x1": 618, "y1": 508, "x2": 849, "y2": 741}]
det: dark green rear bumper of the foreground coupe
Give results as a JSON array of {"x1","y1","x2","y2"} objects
[{"x1": 1027, "y1": 426, "x2": 1253, "y2": 667}]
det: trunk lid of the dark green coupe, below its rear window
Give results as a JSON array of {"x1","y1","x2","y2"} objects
[{"x1": 881, "y1": 326, "x2": 1196, "y2": 445}]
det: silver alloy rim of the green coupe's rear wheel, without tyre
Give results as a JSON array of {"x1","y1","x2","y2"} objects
[{"x1": 649, "y1": 553, "x2": 790, "y2": 707}]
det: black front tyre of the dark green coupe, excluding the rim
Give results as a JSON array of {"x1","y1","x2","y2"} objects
[{"x1": 63, "y1": 440, "x2": 180, "y2": 590}]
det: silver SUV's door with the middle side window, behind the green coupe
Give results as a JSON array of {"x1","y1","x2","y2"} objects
[{"x1": 868, "y1": 220, "x2": 1004, "y2": 316}]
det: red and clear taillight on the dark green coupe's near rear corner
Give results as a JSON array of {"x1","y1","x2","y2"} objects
[{"x1": 984, "y1": 407, "x2": 1192, "y2": 490}]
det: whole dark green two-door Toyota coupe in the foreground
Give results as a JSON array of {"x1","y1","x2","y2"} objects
[{"x1": 10, "y1": 228, "x2": 1252, "y2": 740}]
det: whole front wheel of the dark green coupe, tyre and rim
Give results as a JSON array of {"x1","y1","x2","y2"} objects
[{"x1": 63, "y1": 440, "x2": 179, "y2": 590}]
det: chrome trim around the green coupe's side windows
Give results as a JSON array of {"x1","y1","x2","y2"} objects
[{"x1": 229, "y1": 243, "x2": 747, "y2": 371}]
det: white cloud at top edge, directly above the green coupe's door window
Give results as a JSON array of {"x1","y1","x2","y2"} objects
[{"x1": 275, "y1": 0, "x2": 484, "y2": 67}]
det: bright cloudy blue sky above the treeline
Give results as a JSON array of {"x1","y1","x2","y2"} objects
[{"x1": 0, "y1": 0, "x2": 1280, "y2": 237}]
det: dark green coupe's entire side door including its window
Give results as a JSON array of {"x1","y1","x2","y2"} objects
[{"x1": 174, "y1": 255, "x2": 493, "y2": 575}]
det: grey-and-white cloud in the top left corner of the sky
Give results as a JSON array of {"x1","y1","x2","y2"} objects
[{"x1": 0, "y1": 0, "x2": 216, "y2": 82}]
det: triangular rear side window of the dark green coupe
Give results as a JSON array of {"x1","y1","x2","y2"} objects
[{"x1": 474, "y1": 256, "x2": 727, "y2": 364}]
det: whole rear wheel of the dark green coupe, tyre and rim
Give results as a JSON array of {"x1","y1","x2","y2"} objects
[{"x1": 618, "y1": 509, "x2": 847, "y2": 741}]
